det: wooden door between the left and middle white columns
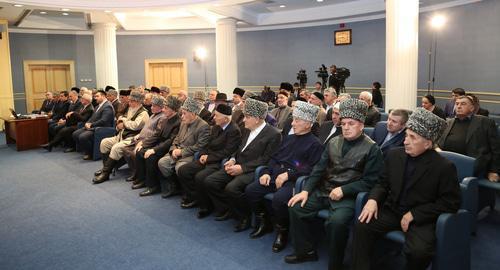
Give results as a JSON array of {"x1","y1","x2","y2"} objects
[{"x1": 145, "y1": 59, "x2": 188, "y2": 95}]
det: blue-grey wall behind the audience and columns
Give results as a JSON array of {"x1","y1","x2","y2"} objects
[{"x1": 10, "y1": 0, "x2": 500, "y2": 112}]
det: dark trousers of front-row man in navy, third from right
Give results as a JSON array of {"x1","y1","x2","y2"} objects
[{"x1": 245, "y1": 180, "x2": 295, "y2": 225}]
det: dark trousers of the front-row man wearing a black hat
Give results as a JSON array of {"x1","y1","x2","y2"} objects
[{"x1": 177, "y1": 160, "x2": 220, "y2": 204}]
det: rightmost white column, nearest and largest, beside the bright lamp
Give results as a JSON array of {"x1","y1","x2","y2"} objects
[{"x1": 385, "y1": 0, "x2": 418, "y2": 111}]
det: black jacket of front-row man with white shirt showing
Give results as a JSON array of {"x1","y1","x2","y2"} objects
[{"x1": 233, "y1": 124, "x2": 281, "y2": 173}]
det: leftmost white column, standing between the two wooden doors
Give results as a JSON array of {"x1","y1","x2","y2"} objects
[{"x1": 93, "y1": 23, "x2": 119, "y2": 89}]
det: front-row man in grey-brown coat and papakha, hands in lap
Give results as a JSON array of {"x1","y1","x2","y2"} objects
[{"x1": 158, "y1": 98, "x2": 210, "y2": 198}]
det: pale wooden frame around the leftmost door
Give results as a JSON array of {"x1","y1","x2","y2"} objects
[{"x1": 23, "y1": 60, "x2": 76, "y2": 112}]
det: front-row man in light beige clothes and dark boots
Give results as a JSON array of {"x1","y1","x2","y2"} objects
[{"x1": 92, "y1": 91, "x2": 149, "y2": 184}]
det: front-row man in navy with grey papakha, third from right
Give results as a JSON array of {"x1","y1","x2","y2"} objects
[{"x1": 245, "y1": 101, "x2": 324, "y2": 252}]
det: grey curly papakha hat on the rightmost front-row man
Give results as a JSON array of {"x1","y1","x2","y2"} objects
[{"x1": 406, "y1": 108, "x2": 447, "y2": 142}]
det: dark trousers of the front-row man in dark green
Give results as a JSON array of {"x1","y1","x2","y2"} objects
[{"x1": 289, "y1": 190, "x2": 354, "y2": 269}]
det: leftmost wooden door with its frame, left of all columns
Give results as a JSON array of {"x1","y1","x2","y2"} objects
[{"x1": 24, "y1": 61, "x2": 75, "y2": 113}]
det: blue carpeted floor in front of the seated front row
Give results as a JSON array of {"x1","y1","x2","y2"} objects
[{"x1": 0, "y1": 133, "x2": 500, "y2": 270}]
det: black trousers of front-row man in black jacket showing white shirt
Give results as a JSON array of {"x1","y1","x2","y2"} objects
[{"x1": 203, "y1": 169, "x2": 255, "y2": 218}]
